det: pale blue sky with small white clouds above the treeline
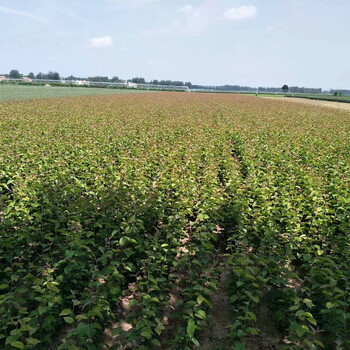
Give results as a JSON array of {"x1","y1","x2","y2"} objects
[{"x1": 0, "y1": 0, "x2": 350, "y2": 89}]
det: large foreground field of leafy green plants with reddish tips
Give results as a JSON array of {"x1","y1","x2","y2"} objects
[{"x1": 0, "y1": 91, "x2": 350, "y2": 350}]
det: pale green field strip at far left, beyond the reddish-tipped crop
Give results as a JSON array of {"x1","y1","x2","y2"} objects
[{"x1": 0, "y1": 84, "x2": 145, "y2": 101}]
